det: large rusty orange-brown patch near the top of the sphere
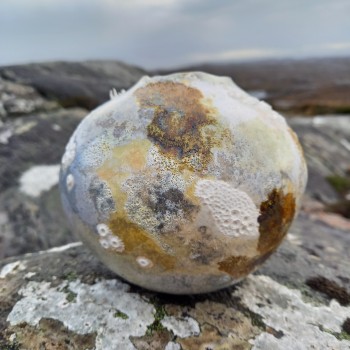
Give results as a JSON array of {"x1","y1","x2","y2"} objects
[{"x1": 135, "y1": 82, "x2": 231, "y2": 170}]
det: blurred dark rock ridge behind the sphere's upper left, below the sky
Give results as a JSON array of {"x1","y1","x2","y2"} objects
[{"x1": 0, "y1": 61, "x2": 147, "y2": 109}]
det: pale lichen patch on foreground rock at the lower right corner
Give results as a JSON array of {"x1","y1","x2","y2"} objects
[{"x1": 233, "y1": 276, "x2": 350, "y2": 350}]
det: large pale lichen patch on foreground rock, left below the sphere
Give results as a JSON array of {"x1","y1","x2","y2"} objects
[{"x1": 7, "y1": 280, "x2": 155, "y2": 350}]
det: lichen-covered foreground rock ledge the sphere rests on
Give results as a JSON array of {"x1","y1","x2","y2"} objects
[{"x1": 0, "y1": 217, "x2": 350, "y2": 350}]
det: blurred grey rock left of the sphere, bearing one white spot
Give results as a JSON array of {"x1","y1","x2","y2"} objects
[{"x1": 0, "y1": 109, "x2": 87, "y2": 259}]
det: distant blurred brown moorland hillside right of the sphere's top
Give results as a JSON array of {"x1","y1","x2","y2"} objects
[{"x1": 162, "y1": 57, "x2": 350, "y2": 115}]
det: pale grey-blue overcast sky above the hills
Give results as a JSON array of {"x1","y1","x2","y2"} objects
[{"x1": 0, "y1": 0, "x2": 350, "y2": 68}]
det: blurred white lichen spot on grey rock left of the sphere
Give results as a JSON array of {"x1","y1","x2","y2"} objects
[{"x1": 19, "y1": 165, "x2": 60, "y2": 197}]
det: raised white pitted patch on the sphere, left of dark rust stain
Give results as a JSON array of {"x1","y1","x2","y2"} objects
[{"x1": 195, "y1": 180, "x2": 259, "y2": 238}]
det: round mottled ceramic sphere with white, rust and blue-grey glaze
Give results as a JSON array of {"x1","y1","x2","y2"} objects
[{"x1": 60, "y1": 72, "x2": 306, "y2": 294}]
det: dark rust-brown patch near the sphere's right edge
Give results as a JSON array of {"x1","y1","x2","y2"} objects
[{"x1": 258, "y1": 189, "x2": 295, "y2": 254}]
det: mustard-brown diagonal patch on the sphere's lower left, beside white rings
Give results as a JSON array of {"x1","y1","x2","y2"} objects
[{"x1": 108, "y1": 215, "x2": 176, "y2": 270}]
